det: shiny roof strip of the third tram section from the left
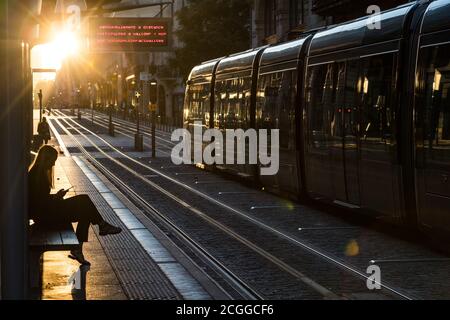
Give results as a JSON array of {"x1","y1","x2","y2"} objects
[{"x1": 260, "y1": 37, "x2": 308, "y2": 66}]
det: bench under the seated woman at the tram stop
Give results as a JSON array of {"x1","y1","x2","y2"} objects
[{"x1": 29, "y1": 224, "x2": 79, "y2": 291}]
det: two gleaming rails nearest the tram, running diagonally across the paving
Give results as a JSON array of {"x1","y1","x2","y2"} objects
[{"x1": 50, "y1": 110, "x2": 413, "y2": 299}]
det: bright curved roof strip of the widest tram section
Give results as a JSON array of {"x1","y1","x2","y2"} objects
[{"x1": 310, "y1": 2, "x2": 416, "y2": 56}]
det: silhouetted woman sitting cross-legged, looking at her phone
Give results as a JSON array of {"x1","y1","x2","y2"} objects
[{"x1": 28, "y1": 146, "x2": 122, "y2": 265}]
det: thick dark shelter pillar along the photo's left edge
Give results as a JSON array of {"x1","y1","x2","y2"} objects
[{"x1": 0, "y1": 0, "x2": 28, "y2": 300}]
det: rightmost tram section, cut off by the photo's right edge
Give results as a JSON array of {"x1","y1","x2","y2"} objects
[{"x1": 414, "y1": 0, "x2": 450, "y2": 234}]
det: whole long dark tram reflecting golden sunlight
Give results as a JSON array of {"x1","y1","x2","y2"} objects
[{"x1": 184, "y1": 0, "x2": 450, "y2": 233}]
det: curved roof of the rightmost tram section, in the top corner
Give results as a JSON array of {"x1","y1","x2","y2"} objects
[{"x1": 421, "y1": 0, "x2": 450, "y2": 33}]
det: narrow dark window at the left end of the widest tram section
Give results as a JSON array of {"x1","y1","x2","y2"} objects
[{"x1": 306, "y1": 64, "x2": 338, "y2": 150}]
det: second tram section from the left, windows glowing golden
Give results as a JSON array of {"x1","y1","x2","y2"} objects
[{"x1": 214, "y1": 47, "x2": 266, "y2": 182}]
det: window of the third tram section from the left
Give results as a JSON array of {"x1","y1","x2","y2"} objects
[{"x1": 256, "y1": 70, "x2": 297, "y2": 150}]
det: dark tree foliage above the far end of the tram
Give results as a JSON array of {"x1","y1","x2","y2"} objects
[{"x1": 171, "y1": 0, "x2": 251, "y2": 79}]
